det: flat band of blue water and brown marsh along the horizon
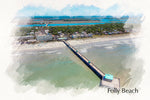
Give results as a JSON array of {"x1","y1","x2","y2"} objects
[{"x1": 14, "y1": 16, "x2": 141, "y2": 27}]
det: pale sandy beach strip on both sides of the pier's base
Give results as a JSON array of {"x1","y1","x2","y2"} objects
[{"x1": 13, "y1": 34, "x2": 138, "y2": 52}]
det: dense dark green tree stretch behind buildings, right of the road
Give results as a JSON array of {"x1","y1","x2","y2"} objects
[{"x1": 48, "y1": 23, "x2": 124, "y2": 35}]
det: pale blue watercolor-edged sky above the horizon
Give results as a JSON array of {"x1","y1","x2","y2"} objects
[{"x1": 16, "y1": 3, "x2": 141, "y2": 16}]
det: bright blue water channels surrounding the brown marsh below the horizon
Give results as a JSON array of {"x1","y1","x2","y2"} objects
[{"x1": 18, "y1": 16, "x2": 142, "y2": 27}]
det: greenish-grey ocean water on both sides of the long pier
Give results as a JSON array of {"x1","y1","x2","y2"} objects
[{"x1": 12, "y1": 39, "x2": 143, "y2": 89}]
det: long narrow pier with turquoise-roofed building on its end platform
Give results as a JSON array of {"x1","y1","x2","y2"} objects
[{"x1": 62, "y1": 40, "x2": 120, "y2": 89}]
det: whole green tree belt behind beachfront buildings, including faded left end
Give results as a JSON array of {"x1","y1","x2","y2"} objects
[{"x1": 15, "y1": 23, "x2": 124, "y2": 36}]
